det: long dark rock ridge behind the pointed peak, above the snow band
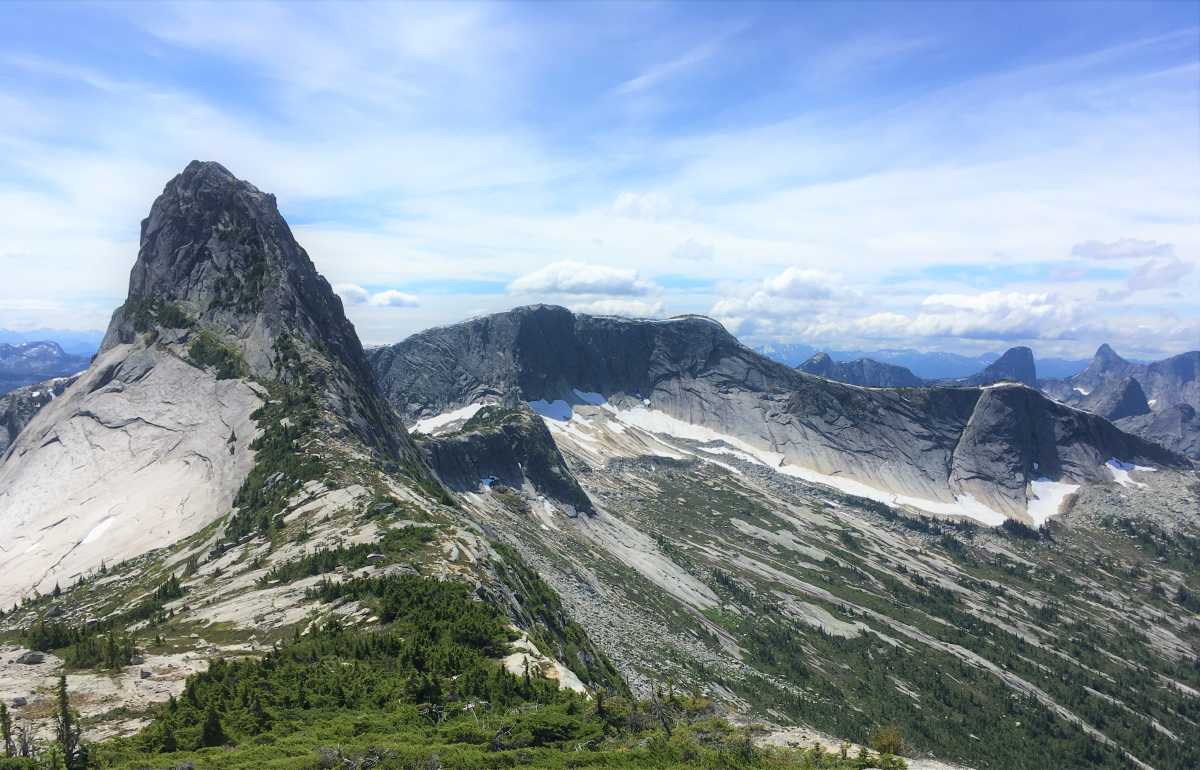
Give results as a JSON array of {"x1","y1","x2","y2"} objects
[{"x1": 371, "y1": 306, "x2": 1186, "y2": 515}]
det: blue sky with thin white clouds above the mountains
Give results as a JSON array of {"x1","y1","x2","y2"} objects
[{"x1": 0, "y1": 2, "x2": 1200, "y2": 356}]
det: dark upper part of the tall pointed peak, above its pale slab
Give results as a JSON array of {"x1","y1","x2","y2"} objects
[{"x1": 94, "y1": 161, "x2": 415, "y2": 456}]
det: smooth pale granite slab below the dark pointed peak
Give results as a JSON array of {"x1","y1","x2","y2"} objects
[{"x1": 0, "y1": 343, "x2": 263, "y2": 606}]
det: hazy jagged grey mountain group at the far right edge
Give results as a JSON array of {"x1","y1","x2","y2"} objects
[{"x1": 1039, "y1": 344, "x2": 1200, "y2": 459}]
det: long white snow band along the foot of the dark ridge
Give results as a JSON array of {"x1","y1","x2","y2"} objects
[{"x1": 520, "y1": 383, "x2": 1094, "y2": 527}]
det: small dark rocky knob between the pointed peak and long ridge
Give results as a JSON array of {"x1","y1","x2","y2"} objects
[{"x1": 419, "y1": 407, "x2": 594, "y2": 513}]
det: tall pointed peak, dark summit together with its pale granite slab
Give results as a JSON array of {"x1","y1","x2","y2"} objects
[{"x1": 0, "y1": 162, "x2": 428, "y2": 601}]
